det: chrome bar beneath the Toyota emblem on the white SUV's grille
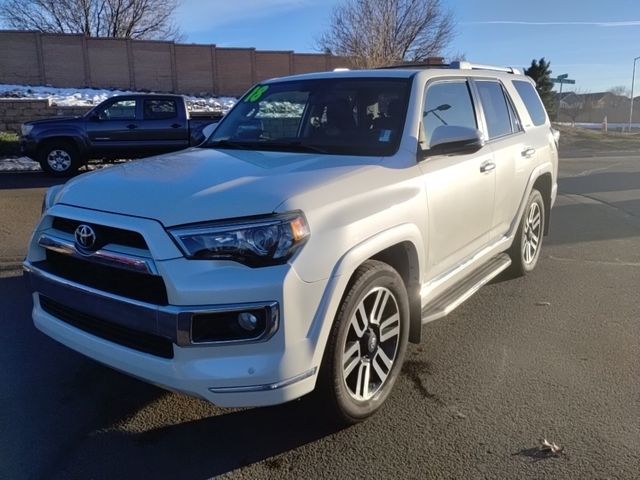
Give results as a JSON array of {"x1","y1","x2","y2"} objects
[{"x1": 38, "y1": 233, "x2": 158, "y2": 275}]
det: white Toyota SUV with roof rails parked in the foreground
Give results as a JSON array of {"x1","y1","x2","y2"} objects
[{"x1": 24, "y1": 63, "x2": 558, "y2": 422}]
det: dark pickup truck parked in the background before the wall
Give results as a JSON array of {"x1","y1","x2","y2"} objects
[{"x1": 20, "y1": 94, "x2": 220, "y2": 176}]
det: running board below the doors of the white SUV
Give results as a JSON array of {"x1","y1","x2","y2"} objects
[{"x1": 422, "y1": 253, "x2": 511, "y2": 324}]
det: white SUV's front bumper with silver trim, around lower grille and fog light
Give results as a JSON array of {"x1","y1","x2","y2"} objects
[{"x1": 25, "y1": 260, "x2": 322, "y2": 407}]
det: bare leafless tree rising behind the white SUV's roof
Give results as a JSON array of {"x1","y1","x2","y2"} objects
[{"x1": 318, "y1": 0, "x2": 454, "y2": 68}]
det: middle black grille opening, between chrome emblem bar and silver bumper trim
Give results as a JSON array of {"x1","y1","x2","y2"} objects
[{"x1": 34, "y1": 250, "x2": 169, "y2": 305}]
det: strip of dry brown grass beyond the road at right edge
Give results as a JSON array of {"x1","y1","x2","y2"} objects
[{"x1": 553, "y1": 125, "x2": 640, "y2": 155}]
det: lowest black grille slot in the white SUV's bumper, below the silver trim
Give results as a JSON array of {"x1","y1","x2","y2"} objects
[{"x1": 40, "y1": 295, "x2": 173, "y2": 358}]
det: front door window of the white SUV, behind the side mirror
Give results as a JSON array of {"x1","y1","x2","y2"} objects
[{"x1": 422, "y1": 82, "x2": 478, "y2": 145}]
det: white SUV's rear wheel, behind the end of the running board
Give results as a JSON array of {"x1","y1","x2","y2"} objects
[{"x1": 507, "y1": 189, "x2": 546, "y2": 277}]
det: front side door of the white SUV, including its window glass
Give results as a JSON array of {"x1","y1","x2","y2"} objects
[{"x1": 420, "y1": 79, "x2": 495, "y2": 281}]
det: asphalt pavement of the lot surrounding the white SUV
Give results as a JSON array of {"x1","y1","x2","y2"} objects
[{"x1": 0, "y1": 157, "x2": 640, "y2": 479}]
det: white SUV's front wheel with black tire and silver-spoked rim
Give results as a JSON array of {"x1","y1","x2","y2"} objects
[{"x1": 316, "y1": 260, "x2": 409, "y2": 424}]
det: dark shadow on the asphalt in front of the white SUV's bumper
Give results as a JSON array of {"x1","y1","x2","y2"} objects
[{"x1": 0, "y1": 276, "x2": 340, "y2": 479}]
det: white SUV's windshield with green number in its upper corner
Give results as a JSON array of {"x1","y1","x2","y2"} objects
[{"x1": 202, "y1": 78, "x2": 411, "y2": 156}]
